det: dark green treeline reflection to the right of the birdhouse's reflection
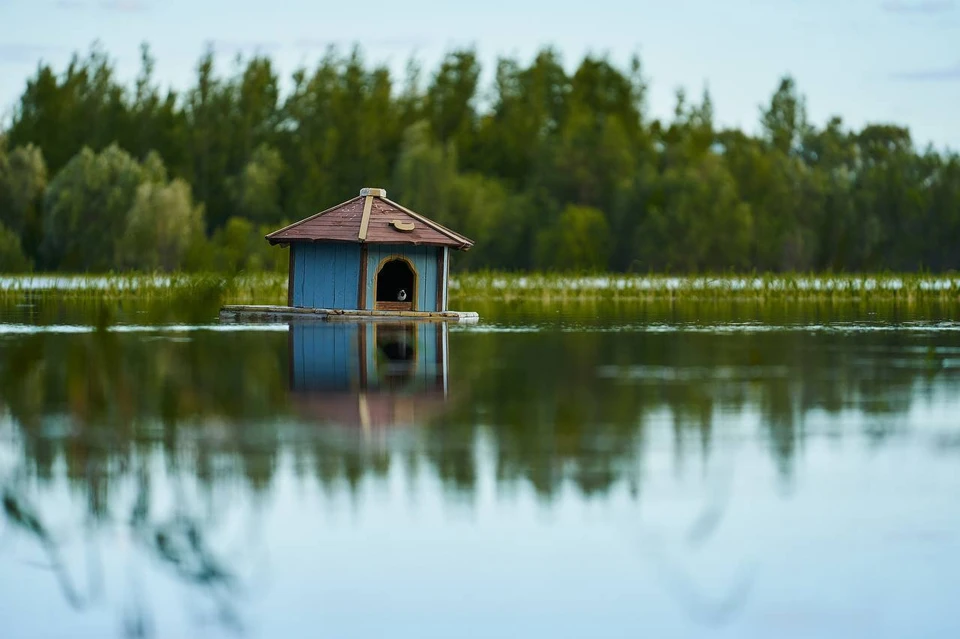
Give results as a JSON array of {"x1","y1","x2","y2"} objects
[{"x1": 440, "y1": 331, "x2": 960, "y2": 495}]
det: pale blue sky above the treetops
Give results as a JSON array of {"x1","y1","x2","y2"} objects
[{"x1": 0, "y1": 0, "x2": 960, "y2": 150}]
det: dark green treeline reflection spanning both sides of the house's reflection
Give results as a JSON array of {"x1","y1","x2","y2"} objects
[{"x1": 0, "y1": 331, "x2": 957, "y2": 508}]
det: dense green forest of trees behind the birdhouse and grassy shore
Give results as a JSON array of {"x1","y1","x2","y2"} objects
[{"x1": 0, "y1": 46, "x2": 960, "y2": 272}]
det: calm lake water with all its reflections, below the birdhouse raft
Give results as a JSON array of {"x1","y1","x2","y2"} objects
[{"x1": 0, "y1": 301, "x2": 960, "y2": 638}]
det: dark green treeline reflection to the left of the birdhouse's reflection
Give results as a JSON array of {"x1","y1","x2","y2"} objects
[{"x1": 0, "y1": 332, "x2": 286, "y2": 500}]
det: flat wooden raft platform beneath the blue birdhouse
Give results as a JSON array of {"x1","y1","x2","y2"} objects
[{"x1": 220, "y1": 304, "x2": 480, "y2": 324}]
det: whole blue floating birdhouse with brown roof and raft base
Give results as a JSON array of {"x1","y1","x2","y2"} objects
[{"x1": 221, "y1": 188, "x2": 476, "y2": 321}]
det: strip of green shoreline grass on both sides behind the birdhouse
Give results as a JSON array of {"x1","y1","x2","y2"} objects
[{"x1": 0, "y1": 273, "x2": 960, "y2": 304}]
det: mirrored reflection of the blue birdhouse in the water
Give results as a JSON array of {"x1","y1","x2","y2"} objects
[{"x1": 289, "y1": 322, "x2": 447, "y2": 429}]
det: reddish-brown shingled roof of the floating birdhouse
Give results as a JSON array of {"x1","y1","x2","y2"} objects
[{"x1": 267, "y1": 189, "x2": 473, "y2": 251}]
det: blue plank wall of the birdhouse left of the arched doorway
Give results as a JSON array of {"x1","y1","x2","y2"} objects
[{"x1": 290, "y1": 242, "x2": 362, "y2": 308}]
